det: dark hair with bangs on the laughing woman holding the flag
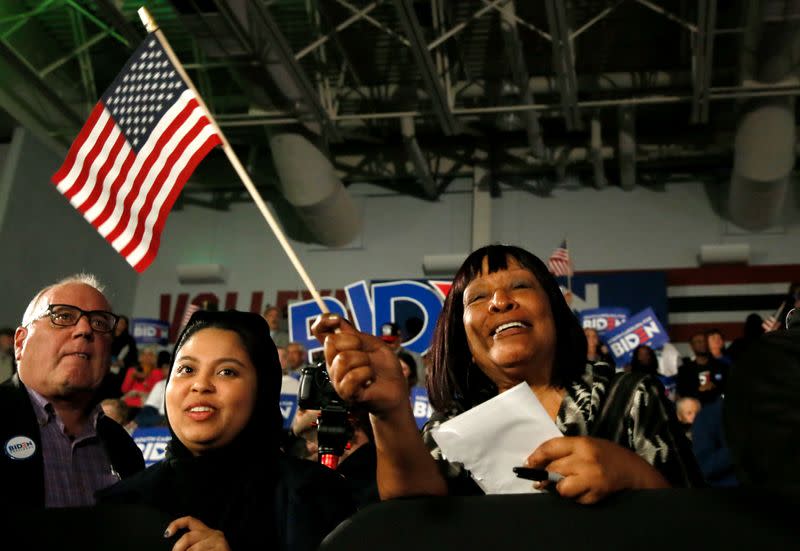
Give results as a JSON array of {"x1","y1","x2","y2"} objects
[{"x1": 427, "y1": 245, "x2": 586, "y2": 411}]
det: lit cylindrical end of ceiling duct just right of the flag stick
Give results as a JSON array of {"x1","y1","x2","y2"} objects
[{"x1": 269, "y1": 132, "x2": 361, "y2": 247}]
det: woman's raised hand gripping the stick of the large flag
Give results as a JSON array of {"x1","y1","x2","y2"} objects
[{"x1": 311, "y1": 314, "x2": 409, "y2": 417}]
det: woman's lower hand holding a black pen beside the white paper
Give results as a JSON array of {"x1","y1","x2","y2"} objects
[{"x1": 525, "y1": 436, "x2": 669, "y2": 504}]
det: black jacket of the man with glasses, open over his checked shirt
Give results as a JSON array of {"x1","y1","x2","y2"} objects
[{"x1": 0, "y1": 375, "x2": 144, "y2": 508}]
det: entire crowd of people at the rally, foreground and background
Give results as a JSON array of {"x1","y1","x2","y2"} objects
[{"x1": 0, "y1": 251, "x2": 800, "y2": 550}]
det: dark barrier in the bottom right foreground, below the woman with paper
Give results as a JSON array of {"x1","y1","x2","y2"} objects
[{"x1": 320, "y1": 489, "x2": 800, "y2": 551}]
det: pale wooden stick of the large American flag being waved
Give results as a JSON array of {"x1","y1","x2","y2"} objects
[{"x1": 138, "y1": 6, "x2": 328, "y2": 314}]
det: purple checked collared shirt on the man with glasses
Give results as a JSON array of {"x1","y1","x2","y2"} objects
[{"x1": 26, "y1": 387, "x2": 120, "y2": 507}]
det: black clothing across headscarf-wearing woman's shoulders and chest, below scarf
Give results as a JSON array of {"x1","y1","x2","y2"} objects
[{"x1": 97, "y1": 454, "x2": 354, "y2": 551}]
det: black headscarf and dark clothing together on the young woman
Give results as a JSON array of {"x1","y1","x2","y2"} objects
[{"x1": 98, "y1": 311, "x2": 353, "y2": 551}]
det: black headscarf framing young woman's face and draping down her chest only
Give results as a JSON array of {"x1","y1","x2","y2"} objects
[{"x1": 161, "y1": 310, "x2": 282, "y2": 550}]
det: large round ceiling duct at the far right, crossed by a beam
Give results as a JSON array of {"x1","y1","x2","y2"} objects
[{"x1": 728, "y1": 0, "x2": 800, "y2": 230}]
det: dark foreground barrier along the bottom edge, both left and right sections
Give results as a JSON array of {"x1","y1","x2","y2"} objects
[{"x1": 0, "y1": 489, "x2": 800, "y2": 551}]
